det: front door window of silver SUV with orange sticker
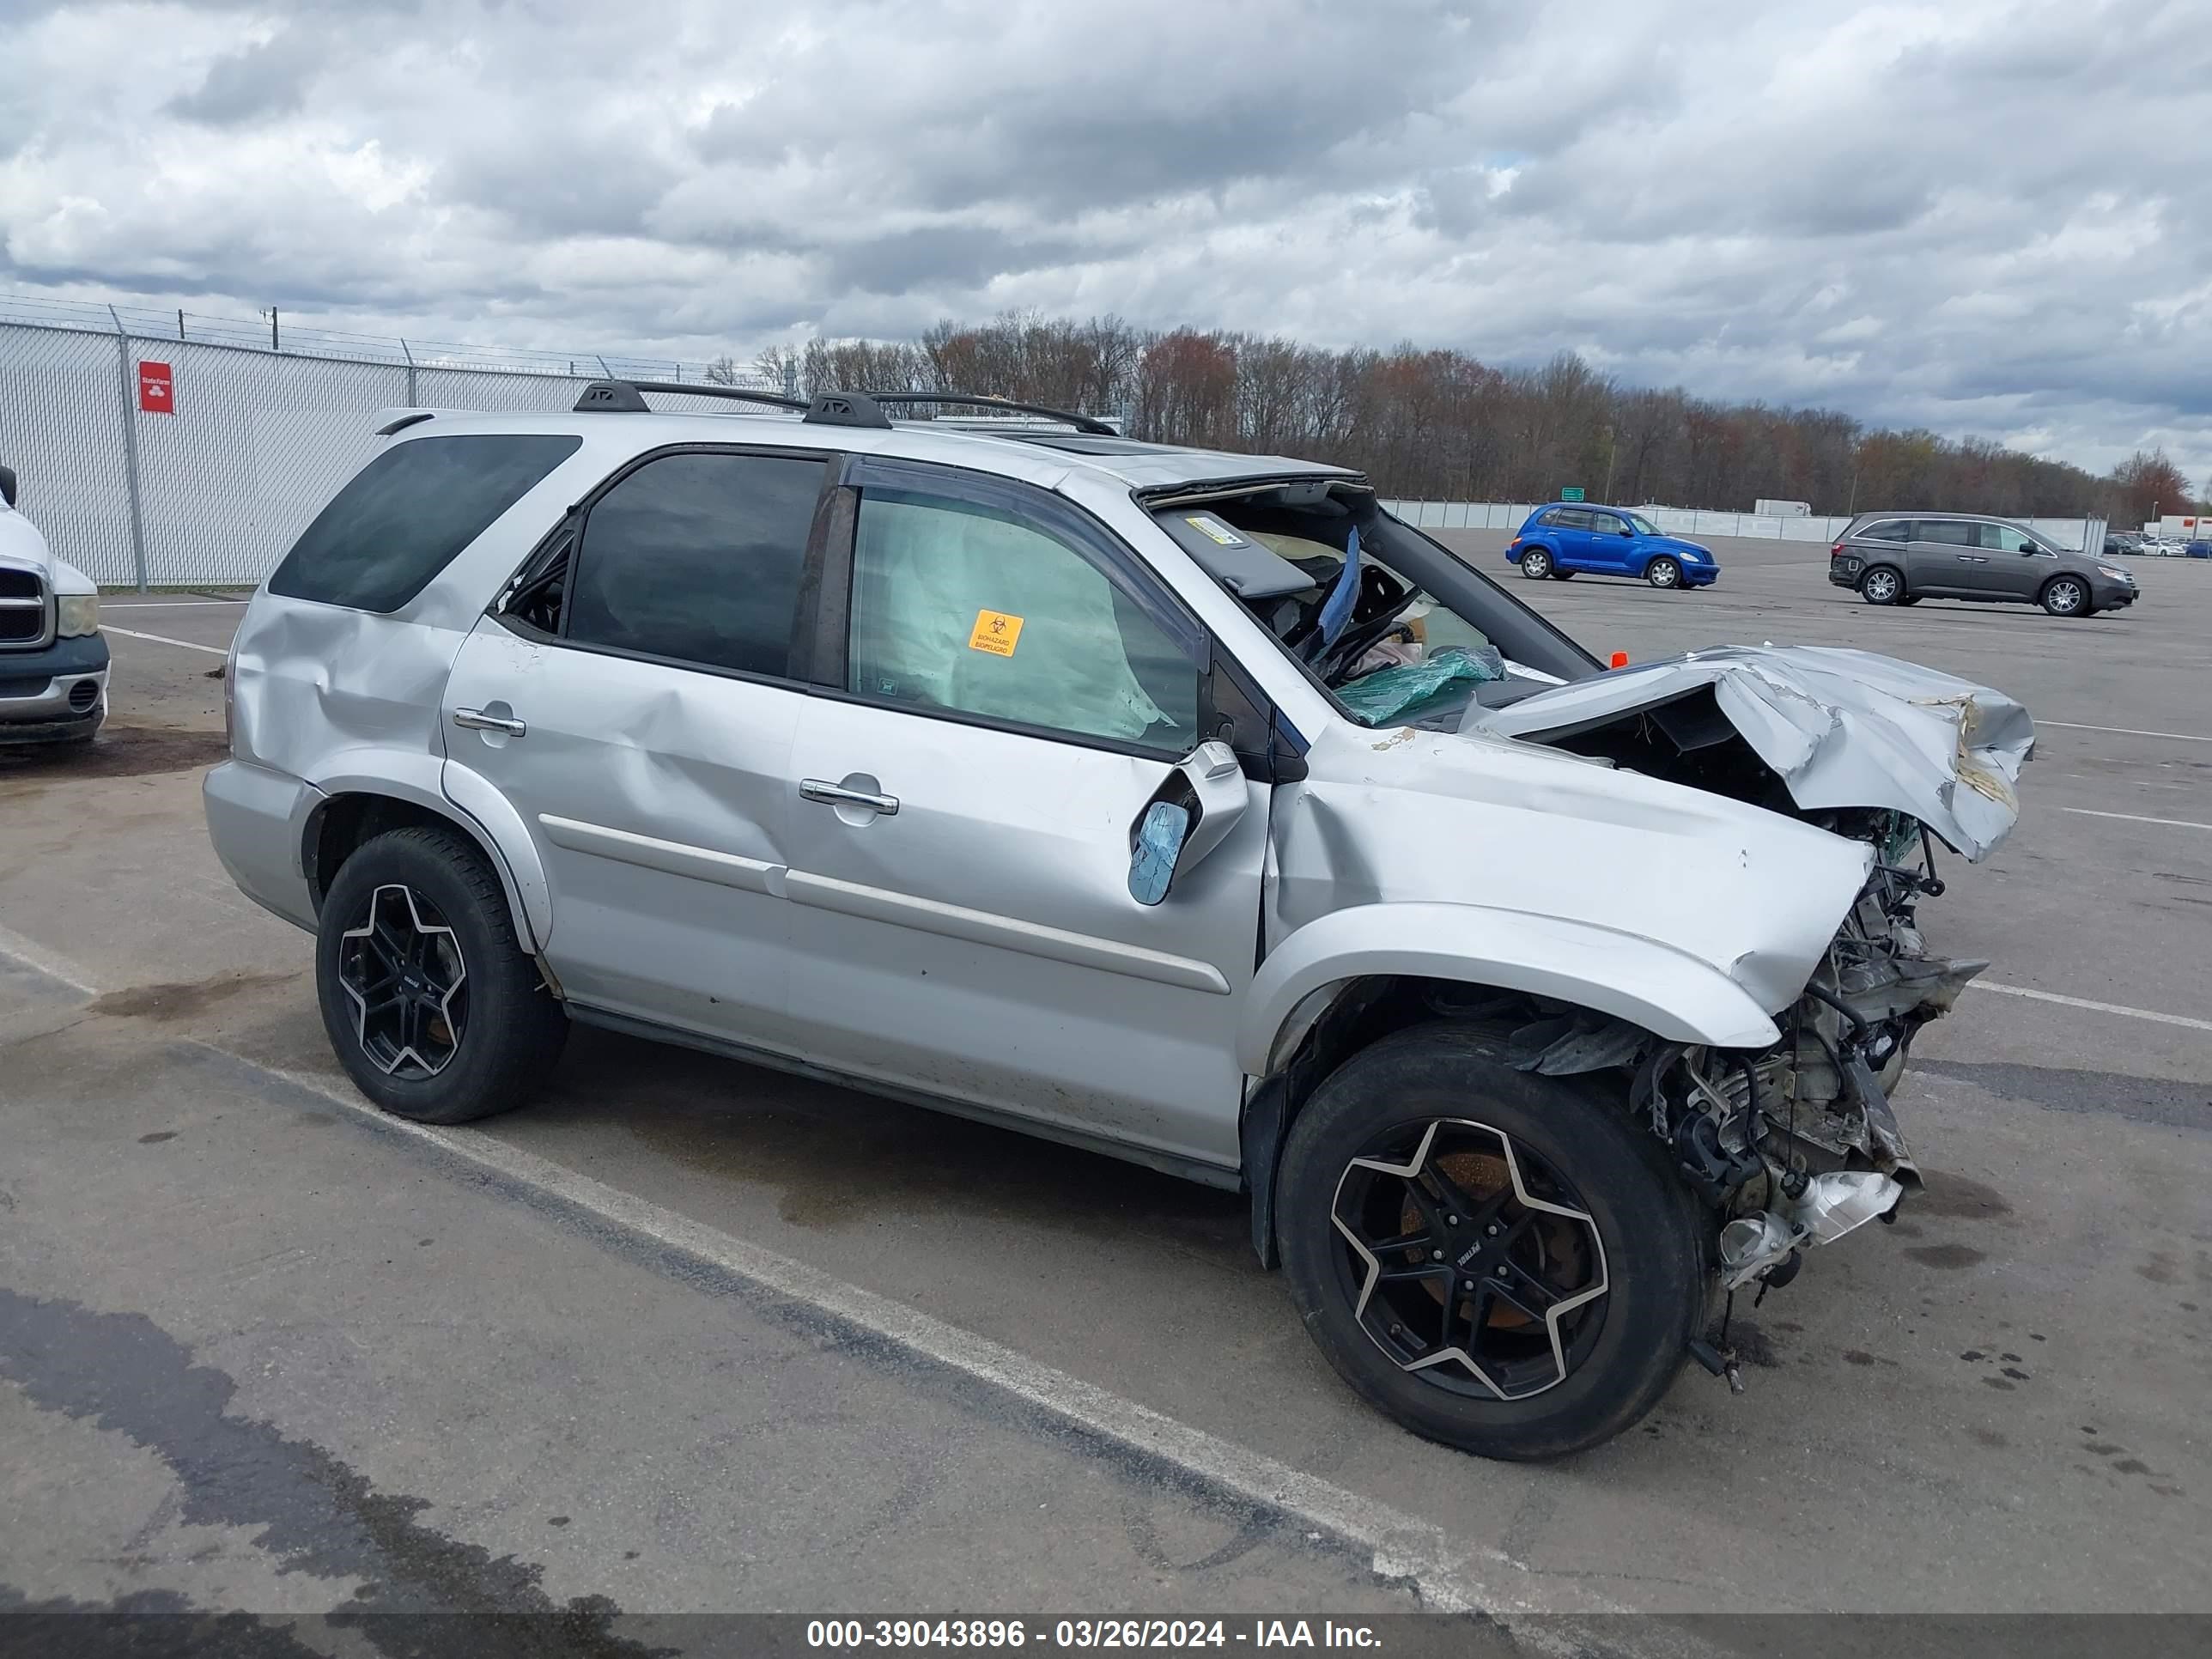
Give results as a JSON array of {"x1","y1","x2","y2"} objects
[{"x1": 848, "y1": 487, "x2": 1199, "y2": 754}]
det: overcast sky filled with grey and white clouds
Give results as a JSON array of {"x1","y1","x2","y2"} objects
[{"x1": 0, "y1": 0, "x2": 2212, "y2": 489}]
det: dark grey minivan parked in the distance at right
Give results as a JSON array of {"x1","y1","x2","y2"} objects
[{"x1": 1827, "y1": 511, "x2": 2136, "y2": 617}]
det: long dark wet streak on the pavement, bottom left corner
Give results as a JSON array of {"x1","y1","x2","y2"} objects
[{"x1": 0, "y1": 1290, "x2": 654, "y2": 1659}]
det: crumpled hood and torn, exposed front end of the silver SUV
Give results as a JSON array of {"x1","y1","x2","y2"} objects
[{"x1": 1464, "y1": 646, "x2": 2035, "y2": 1327}]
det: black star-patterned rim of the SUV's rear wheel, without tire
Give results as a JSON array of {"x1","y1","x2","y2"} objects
[{"x1": 338, "y1": 883, "x2": 469, "y2": 1082}]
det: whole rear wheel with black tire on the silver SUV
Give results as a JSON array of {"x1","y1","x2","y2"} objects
[{"x1": 314, "y1": 825, "x2": 568, "y2": 1124}]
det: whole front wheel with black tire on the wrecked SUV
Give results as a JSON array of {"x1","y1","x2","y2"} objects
[{"x1": 1276, "y1": 1022, "x2": 1712, "y2": 1460}]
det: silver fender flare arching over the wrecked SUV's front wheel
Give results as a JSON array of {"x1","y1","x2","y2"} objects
[{"x1": 1237, "y1": 905, "x2": 1781, "y2": 1078}]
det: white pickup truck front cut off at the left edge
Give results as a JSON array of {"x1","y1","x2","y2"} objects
[{"x1": 0, "y1": 467, "x2": 108, "y2": 745}]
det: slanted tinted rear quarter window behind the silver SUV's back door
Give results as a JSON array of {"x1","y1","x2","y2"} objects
[{"x1": 270, "y1": 434, "x2": 584, "y2": 611}]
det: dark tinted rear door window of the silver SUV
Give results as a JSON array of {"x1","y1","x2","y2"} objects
[{"x1": 566, "y1": 453, "x2": 825, "y2": 679}]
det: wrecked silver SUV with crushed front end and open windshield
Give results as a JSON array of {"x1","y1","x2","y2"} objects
[{"x1": 206, "y1": 383, "x2": 2031, "y2": 1458}]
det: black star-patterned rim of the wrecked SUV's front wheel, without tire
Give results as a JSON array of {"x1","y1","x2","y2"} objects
[{"x1": 1329, "y1": 1117, "x2": 1608, "y2": 1401}]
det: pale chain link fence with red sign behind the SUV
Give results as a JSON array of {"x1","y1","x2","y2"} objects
[{"x1": 0, "y1": 296, "x2": 785, "y2": 586}]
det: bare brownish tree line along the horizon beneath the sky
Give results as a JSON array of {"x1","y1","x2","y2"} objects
[{"x1": 717, "y1": 312, "x2": 2212, "y2": 522}]
